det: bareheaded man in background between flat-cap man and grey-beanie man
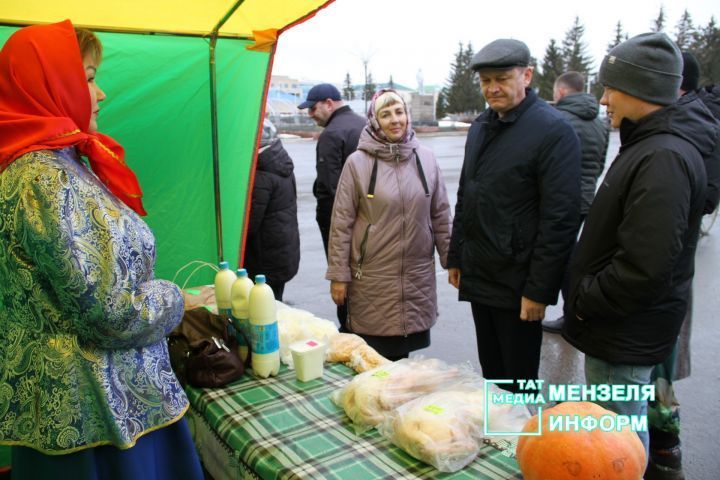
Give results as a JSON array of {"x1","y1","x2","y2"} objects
[{"x1": 542, "y1": 72, "x2": 610, "y2": 333}]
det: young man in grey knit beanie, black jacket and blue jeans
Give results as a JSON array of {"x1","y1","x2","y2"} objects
[{"x1": 563, "y1": 33, "x2": 720, "y2": 464}]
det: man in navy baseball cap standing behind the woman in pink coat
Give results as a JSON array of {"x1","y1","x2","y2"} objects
[{"x1": 298, "y1": 83, "x2": 366, "y2": 332}]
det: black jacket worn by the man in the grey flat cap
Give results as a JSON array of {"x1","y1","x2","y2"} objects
[{"x1": 448, "y1": 90, "x2": 580, "y2": 310}]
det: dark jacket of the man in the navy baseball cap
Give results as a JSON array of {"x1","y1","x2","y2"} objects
[{"x1": 313, "y1": 105, "x2": 367, "y2": 202}]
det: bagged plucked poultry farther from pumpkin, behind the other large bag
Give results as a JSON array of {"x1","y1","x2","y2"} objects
[{"x1": 332, "y1": 358, "x2": 478, "y2": 433}]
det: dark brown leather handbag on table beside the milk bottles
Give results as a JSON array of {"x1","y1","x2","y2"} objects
[{"x1": 168, "y1": 308, "x2": 245, "y2": 387}]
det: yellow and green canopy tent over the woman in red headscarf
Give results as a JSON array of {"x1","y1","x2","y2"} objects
[{"x1": 0, "y1": 0, "x2": 332, "y2": 283}]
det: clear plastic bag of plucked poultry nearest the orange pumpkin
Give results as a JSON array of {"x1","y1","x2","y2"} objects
[{"x1": 378, "y1": 385, "x2": 530, "y2": 472}]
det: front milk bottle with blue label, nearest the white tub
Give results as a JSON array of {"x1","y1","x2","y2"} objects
[{"x1": 250, "y1": 275, "x2": 280, "y2": 378}]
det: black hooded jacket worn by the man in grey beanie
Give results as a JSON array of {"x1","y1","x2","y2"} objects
[{"x1": 563, "y1": 99, "x2": 718, "y2": 365}]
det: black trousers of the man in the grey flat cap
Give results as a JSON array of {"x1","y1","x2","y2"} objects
[{"x1": 471, "y1": 302, "x2": 542, "y2": 393}]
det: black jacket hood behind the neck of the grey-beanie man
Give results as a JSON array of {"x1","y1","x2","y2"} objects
[{"x1": 620, "y1": 95, "x2": 720, "y2": 156}]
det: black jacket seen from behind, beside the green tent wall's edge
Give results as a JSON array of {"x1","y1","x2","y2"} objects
[{"x1": 244, "y1": 140, "x2": 300, "y2": 285}]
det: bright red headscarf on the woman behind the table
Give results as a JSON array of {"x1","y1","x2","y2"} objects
[{"x1": 0, "y1": 20, "x2": 146, "y2": 215}]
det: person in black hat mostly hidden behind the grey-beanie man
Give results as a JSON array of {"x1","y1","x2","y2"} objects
[{"x1": 645, "y1": 48, "x2": 720, "y2": 480}]
